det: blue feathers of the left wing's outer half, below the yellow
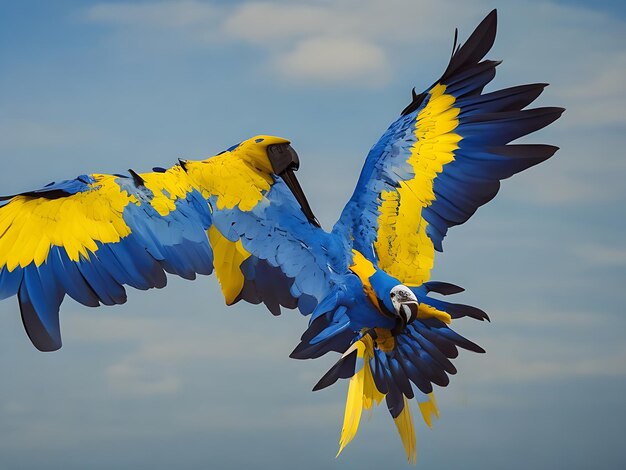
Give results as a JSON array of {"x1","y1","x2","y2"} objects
[{"x1": 0, "y1": 169, "x2": 213, "y2": 351}]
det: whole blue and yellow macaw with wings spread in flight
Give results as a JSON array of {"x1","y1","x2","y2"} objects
[{"x1": 0, "y1": 10, "x2": 563, "y2": 461}]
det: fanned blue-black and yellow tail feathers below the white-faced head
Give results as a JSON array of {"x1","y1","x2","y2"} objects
[{"x1": 310, "y1": 282, "x2": 488, "y2": 463}]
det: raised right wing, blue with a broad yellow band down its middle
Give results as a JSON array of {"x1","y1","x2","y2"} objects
[{"x1": 334, "y1": 10, "x2": 563, "y2": 285}]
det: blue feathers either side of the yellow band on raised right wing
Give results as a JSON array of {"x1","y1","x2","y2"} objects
[{"x1": 334, "y1": 9, "x2": 563, "y2": 262}]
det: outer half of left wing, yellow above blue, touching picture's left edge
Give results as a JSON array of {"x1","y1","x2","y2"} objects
[{"x1": 0, "y1": 167, "x2": 213, "y2": 351}]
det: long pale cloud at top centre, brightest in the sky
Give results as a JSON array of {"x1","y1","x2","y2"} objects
[{"x1": 83, "y1": 0, "x2": 465, "y2": 87}]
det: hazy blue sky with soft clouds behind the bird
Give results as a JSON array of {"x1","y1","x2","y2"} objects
[{"x1": 0, "y1": 0, "x2": 626, "y2": 469}]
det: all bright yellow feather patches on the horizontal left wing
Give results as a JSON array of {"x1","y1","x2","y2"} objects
[{"x1": 0, "y1": 136, "x2": 288, "y2": 280}]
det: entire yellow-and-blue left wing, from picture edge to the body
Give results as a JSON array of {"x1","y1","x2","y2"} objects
[{"x1": 0, "y1": 136, "x2": 346, "y2": 351}]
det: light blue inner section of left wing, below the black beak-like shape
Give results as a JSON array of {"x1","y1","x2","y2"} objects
[{"x1": 210, "y1": 178, "x2": 349, "y2": 315}]
